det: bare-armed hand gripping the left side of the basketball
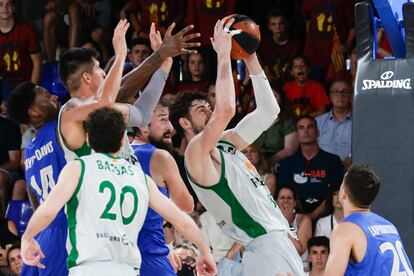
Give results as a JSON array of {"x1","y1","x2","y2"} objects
[{"x1": 210, "y1": 16, "x2": 242, "y2": 56}]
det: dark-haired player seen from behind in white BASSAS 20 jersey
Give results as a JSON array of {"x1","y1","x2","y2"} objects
[{"x1": 22, "y1": 108, "x2": 216, "y2": 276}]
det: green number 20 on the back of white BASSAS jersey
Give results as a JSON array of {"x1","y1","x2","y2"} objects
[{"x1": 99, "y1": 181, "x2": 138, "y2": 225}]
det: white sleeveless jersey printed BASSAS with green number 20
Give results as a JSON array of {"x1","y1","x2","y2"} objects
[{"x1": 66, "y1": 153, "x2": 149, "y2": 268}]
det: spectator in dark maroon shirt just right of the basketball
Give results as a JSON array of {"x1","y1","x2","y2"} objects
[{"x1": 259, "y1": 10, "x2": 303, "y2": 83}]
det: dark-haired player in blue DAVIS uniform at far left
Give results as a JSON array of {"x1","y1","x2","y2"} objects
[{"x1": 9, "y1": 82, "x2": 68, "y2": 276}]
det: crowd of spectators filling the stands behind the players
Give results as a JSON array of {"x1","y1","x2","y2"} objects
[{"x1": 0, "y1": 0, "x2": 392, "y2": 275}]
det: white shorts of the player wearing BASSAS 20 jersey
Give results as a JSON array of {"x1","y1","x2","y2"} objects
[{"x1": 69, "y1": 261, "x2": 139, "y2": 276}]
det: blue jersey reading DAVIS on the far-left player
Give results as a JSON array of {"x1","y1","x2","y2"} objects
[{"x1": 24, "y1": 121, "x2": 66, "y2": 225}]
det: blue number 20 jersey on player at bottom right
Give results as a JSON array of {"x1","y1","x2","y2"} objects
[{"x1": 342, "y1": 212, "x2": 413, "y2": 276}]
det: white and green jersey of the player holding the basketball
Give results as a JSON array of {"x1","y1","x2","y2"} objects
[{"x1": 188, "y1": 141, "x2": 289, "y2": 245}]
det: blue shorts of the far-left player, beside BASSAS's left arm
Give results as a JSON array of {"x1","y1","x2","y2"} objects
[{"x1": 21, "y1": 223, "x2": 69, "y2": 276}]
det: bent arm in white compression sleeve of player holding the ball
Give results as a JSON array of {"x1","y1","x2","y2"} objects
[{"x1": 223, "y1": 53, "x2": 280, "y2": 150}]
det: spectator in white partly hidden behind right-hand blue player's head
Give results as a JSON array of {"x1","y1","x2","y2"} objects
[{"x1": 314, "y1": 185, "x2": 344, "y2": 238}]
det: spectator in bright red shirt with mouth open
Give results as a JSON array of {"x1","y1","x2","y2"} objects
[{"x1": 284, "y1": 56, "x2": 329, "y2": 117}]
